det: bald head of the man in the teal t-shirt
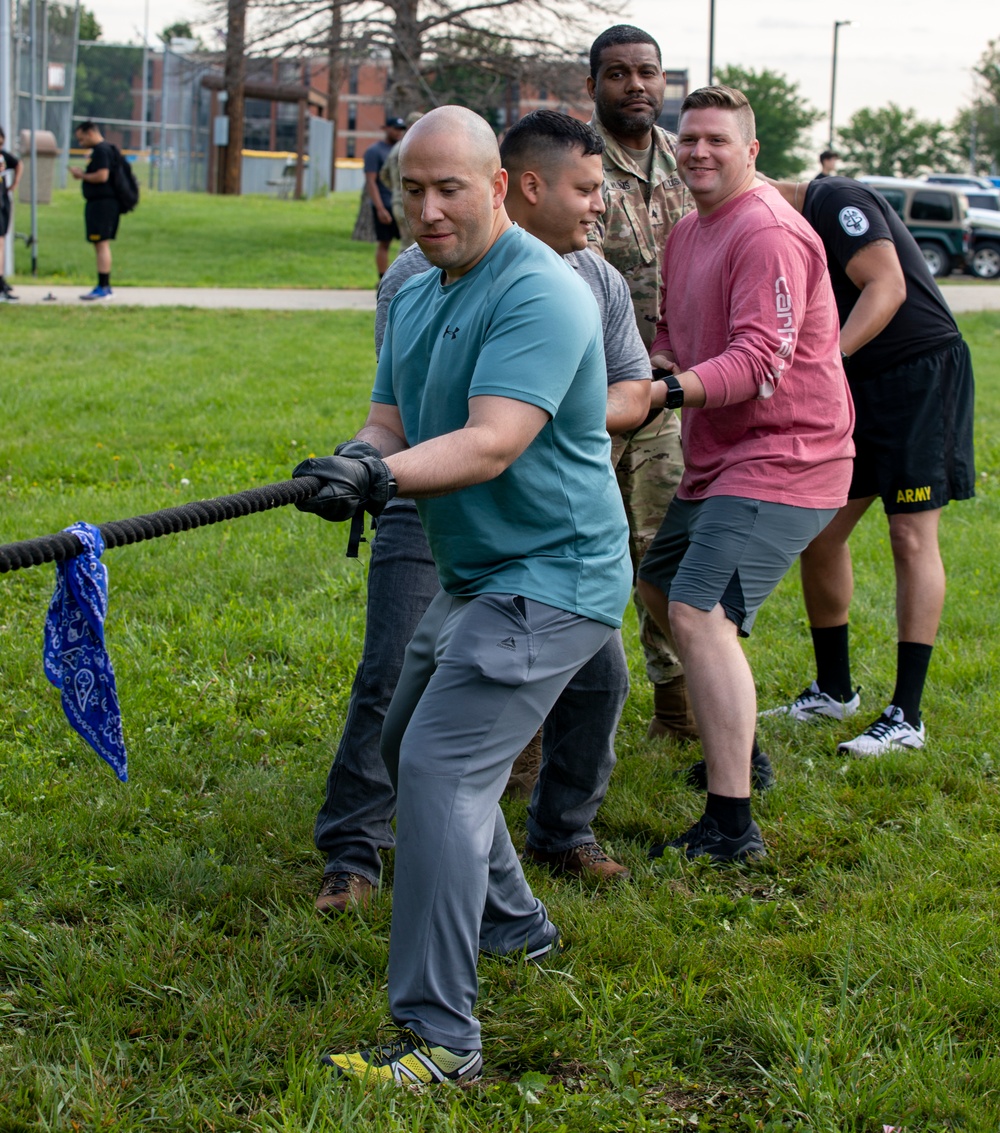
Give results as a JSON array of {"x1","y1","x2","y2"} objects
[{"x1": 400, "y1": 107, "x2": 511, "y2": 282}]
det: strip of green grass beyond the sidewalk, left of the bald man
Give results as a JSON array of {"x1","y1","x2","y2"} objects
[{"x1": 15, "y1": 187, "x2": 378, "y2": 288}]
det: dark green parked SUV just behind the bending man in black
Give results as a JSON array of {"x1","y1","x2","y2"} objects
[{"x1": 857, "y1": 177, "x2": 972, "y2": 279}]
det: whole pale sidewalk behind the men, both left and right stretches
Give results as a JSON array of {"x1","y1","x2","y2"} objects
[{"x1": 7, "y1": 283, "x2": 1000, "y2": 315}]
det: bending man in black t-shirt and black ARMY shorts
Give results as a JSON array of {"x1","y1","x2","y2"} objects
[{"x1": 771, "y1": 177, "x2": 975, "y2": 756}]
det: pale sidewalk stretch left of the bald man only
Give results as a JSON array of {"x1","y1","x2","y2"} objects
[{"x1": 14, "y1": 284, "x2": 375, "y2": 310}]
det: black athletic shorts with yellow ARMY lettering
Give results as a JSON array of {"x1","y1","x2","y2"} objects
[{"x1": 848, "y1": 338, "x2": 976, "y2": 516}]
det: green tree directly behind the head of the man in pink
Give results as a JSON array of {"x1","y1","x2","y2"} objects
[{"x1": 715, "y1": 66, "x2": 823, "y2": 180}]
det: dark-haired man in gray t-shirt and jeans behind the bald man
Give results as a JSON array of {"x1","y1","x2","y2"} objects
[{"x1": 315, "y1": 111, "x2": 651, "y2": 913}]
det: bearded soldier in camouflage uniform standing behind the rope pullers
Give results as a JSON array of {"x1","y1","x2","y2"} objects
[{"x1": 587, "y1": 24, "x2": 698, "y2": 738}]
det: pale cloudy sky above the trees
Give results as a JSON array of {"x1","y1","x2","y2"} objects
[{"x1": 86, "y1": 0, "x2": 1000, "y2": 137}]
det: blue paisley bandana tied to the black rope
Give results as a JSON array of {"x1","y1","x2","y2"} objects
[{"x1": 45, "y1": 523, "x2": 128, "y2": 783}]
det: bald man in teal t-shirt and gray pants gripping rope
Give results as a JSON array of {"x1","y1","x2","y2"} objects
[{"x1": 296, "y1": 107, "x2": 632, "y2": 1082}]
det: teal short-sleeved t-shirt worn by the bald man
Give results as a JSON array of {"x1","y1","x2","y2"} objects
[{"x1": 371, "y1": 228, "x2": 624, "y2": 627}]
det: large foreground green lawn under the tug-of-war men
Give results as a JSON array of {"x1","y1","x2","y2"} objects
[{"x1": 0, "y1": 308, "x2": 1000, "y2": 1133}]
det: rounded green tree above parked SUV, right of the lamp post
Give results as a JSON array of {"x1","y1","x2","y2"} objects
[{"x1": 837, "y1": 102, "x2": 961, "y2": 177}]
